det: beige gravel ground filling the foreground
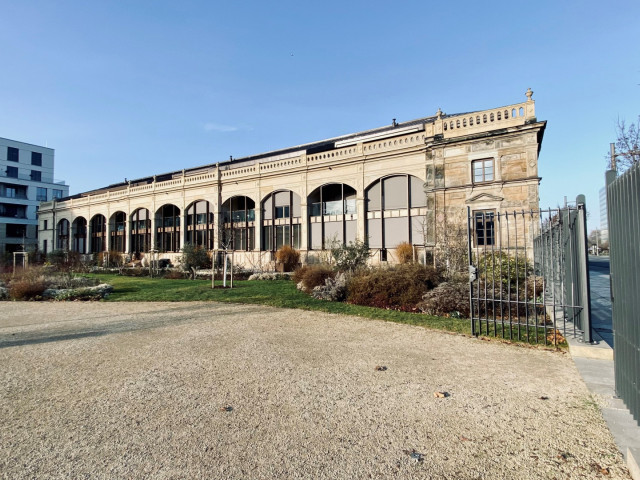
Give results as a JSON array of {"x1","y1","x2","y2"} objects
[{"x1": 0, "y1": 302, "x2": 629, "y2": 479}]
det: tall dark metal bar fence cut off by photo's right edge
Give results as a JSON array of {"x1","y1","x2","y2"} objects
[{"x1": 607, "y1": 164, "x2": 640, "y2": 421}]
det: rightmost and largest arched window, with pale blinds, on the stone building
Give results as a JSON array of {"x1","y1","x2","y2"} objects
[{"x1": 365, "y1": 175, "x2": 427, "y2": 248}]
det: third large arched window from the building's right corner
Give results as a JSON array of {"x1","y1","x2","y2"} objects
[{"x1": 262, "y1": 190, "x2": 302, "y2": 251}]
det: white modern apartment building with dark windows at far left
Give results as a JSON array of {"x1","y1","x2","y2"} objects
[{"x1": 0, "y1": 137, "x2": 69, "y2": 255}]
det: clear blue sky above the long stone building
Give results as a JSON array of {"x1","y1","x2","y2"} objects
[{"x1": 0, "y1": 0, "x2": 640, "y2": 228}]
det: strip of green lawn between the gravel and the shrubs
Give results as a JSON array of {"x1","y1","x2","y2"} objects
[{"x1": 88, "y1": 274, "x2": 566, "y2": 348}]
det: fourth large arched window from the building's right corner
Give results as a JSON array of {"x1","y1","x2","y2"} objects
[{"x1": 220, "y1": 196, "x2": 256, "y2": 250}]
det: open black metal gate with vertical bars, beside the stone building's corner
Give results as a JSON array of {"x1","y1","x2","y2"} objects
[{"x1": 467, "y1": 195, "x2": 591, "y2": 345}]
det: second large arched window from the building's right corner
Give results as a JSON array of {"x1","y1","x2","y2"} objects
[{"x1": 307, "y1": 183, "x2": 357, "y2": 250}]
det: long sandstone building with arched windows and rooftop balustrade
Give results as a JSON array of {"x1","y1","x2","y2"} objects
[{"x1": 39, "y1": 89, "x2": 546, "y2": 267}]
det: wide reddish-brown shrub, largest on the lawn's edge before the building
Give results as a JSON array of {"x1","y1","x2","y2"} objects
[{"x1": 347, "y1": 263, "x2": 441, "y2": 311}]
